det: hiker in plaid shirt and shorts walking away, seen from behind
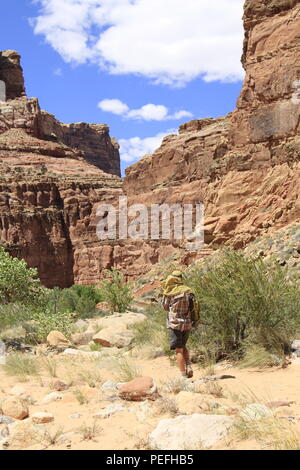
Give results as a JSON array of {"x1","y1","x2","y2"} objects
[{"x1": 161, "y1": 271, "x2": 198, "y2": 378}]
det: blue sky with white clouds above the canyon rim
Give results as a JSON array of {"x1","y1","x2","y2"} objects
[{"x1": 0, "y1": 0, "x2": 243, "y2": 171}]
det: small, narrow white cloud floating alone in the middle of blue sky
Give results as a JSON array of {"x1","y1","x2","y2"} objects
[{"x1": 98, "y1": 99, "x2": 193, "y2": 121}]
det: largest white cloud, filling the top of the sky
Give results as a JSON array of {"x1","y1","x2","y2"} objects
[{"x1": 31, "y1": 0, "x2": 244, "y2": 86}]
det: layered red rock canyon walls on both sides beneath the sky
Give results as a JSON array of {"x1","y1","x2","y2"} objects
[{"x1": 0, "y1": 0, "x2": 300, "y2": 287}]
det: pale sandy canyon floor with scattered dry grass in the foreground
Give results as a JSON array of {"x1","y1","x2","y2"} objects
[{"x1": 0, "y1": 314, "x2": 300, "y2": 450}]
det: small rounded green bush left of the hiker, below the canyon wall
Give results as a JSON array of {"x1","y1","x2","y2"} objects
[{"x1": 100, "y1": 268, "x2": 133, "y2": 312}]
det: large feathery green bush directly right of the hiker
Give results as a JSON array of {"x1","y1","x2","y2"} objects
[{"x1": 186, "y1": 250, "x2": 300, "y2": 359}]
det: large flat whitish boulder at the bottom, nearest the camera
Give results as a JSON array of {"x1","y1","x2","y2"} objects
[{"x1": 149, "y1": 414, "x2": 233, "y2": 450}]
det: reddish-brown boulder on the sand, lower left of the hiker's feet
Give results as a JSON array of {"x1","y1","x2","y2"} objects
[{"x1": 119, "y1": 377, "x2": 159, "y2": 401}]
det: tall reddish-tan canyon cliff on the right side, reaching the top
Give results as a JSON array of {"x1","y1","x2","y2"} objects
[{"x1": 124, "y1": 0, "x2": 300, "y2": 247}]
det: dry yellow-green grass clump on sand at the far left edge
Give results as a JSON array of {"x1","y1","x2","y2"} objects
[{"x1": 3, "y1": 353, "x2": 40, "y2": 379}]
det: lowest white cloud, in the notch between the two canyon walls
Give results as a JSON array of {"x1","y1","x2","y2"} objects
[{"x1": 118, "y1": 129, "x2": 177, "y2": 163}]
